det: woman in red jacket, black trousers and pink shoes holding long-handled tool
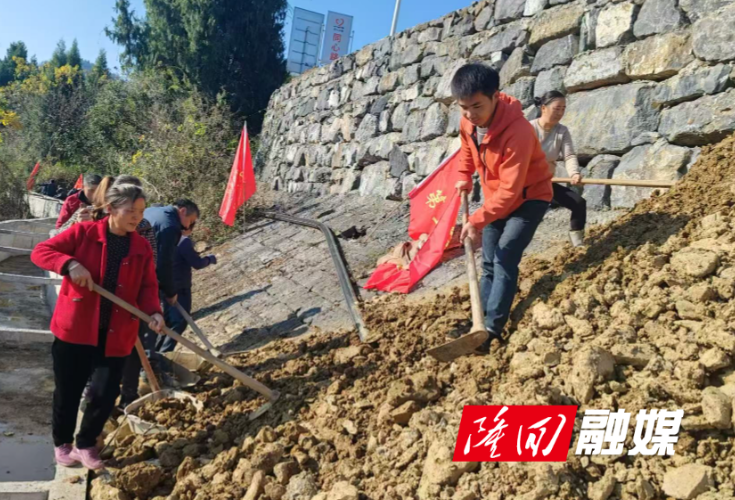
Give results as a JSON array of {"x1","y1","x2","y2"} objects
[{"x1": 31, "y1": 184, "x2": 164, "y2": 469}]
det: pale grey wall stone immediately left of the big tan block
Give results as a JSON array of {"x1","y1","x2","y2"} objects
[{"x1": 564, "y1": 47, "x2": 630, "y2": 92}]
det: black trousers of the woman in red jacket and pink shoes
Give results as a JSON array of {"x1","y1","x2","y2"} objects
[{"x1": 51, "y1": 339, "x2": 126, "y2": 448}]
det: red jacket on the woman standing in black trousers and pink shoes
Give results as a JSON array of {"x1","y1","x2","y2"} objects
[{"x1": 31, "y1": 218, "x2": 161, "y2": 358}]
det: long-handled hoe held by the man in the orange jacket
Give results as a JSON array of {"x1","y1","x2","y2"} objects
[{"x1": 427, "y1": 191, "x2": 490, "y2": 363}]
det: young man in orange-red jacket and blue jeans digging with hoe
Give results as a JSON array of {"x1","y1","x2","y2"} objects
[{"x1": 452, "y1": 64, "x2": 553, "y2": 350}]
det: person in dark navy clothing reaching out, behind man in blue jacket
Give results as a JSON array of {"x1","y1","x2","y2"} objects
[{"x1": 168, "y1": 231, "x2": 217, "y2": 342}]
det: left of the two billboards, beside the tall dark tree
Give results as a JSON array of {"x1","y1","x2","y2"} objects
[{"x1": 286, "y1": 7, "x2": 324, "y2": 75}]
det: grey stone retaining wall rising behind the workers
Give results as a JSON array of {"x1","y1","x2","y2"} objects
[{"x1": 258, "y1": 0, "x2": 735, "y2": 208}]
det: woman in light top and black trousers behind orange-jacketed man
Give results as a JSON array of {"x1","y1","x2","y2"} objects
[{"x1": 531, "y1": 90, "x2": 587, "y2": 247}]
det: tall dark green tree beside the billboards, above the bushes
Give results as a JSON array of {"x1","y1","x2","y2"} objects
[{"x1": 108, "y1": 0, "x2": 287, "y2": 132}]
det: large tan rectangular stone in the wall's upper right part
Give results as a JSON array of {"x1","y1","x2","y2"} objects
[{"x1": 623, "y1": 33, "x2": 694, "y2": 80}]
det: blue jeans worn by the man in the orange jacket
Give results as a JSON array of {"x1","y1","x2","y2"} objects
[{"x1": 480, "y1": 200, "x2": 549, "y2": 335}]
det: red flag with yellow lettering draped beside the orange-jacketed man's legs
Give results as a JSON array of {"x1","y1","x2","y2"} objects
[{"x1": 365, "y1": 152, "x2": 461, "y2": 293}]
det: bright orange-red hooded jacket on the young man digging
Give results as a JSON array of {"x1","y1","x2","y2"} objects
[{"x1": 459, "y1": 93, "x2": 553, "y2": 229}]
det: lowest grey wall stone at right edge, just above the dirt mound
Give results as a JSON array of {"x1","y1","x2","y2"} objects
[{"x1": 659, "y1": 89, "x2": 735, "y2": 146}]
